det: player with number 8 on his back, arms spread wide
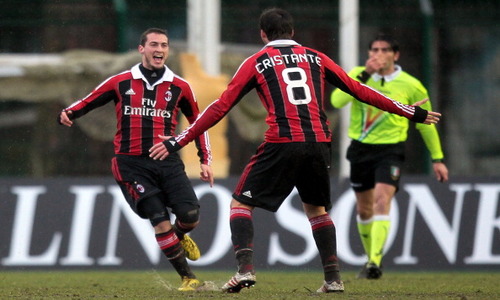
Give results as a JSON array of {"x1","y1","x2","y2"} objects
[{"x1": 151, "y1": 9, "x2": 440, "y2": 292}]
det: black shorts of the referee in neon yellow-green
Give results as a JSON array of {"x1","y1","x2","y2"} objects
[{"x1": 347, "y1": 140, "x2": 405, "y2": 192}]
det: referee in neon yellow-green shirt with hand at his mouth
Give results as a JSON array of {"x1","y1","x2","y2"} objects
[{"x1": 331, "y1": 34, "x2": 448, "y2": 279}]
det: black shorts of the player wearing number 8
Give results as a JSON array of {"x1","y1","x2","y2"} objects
[{"x1": 233, "y1": 142, "x2": 332, "y2": 212}]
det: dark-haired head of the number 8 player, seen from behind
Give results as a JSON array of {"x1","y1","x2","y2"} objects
[{"x1": 259, "y1": 8, "x2": 293, "y2": 41}]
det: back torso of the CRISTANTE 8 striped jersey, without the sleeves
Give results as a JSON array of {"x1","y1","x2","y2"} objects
[{"x1": 247, "y1": 40, "x2": 331, "y2": 142}]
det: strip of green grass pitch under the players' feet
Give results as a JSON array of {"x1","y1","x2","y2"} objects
[{"x1": 0, "y1": 270, "x2": 500, "y2": 300}]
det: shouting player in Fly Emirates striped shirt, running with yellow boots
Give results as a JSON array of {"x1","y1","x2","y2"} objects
[{"x1": 59, "y1": 28, "x2": 213, "y2": 291}]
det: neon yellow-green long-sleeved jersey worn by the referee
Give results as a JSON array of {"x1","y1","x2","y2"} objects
[{"x1": 331, "y1": 65, "x2": 444, "y2": 159}]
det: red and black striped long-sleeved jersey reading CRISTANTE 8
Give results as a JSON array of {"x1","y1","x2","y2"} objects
[{"x1": 173, "y1": 40, "x2": 427, "y2": 151}]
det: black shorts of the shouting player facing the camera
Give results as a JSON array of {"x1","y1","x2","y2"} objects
[{"x1": 111, "y1": 153, "x2": 200, "y2": 218}]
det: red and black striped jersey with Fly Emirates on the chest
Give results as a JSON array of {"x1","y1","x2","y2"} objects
[{"x1": 66, "y1": 64, "x2": 212, "y2": 164}]
